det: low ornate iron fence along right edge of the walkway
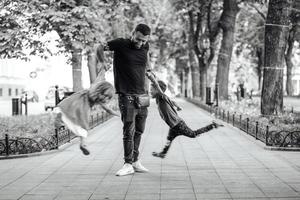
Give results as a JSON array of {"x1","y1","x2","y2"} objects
[{"x1": 187, "y1": 99, "x2": 300, "y2": 147}]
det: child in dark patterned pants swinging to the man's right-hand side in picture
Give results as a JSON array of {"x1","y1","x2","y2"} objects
[{"x1": 146, "y1": 71, "x2": 223, "y2": 158}]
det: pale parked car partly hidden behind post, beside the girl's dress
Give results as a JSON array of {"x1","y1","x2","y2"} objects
[{"x1": 44, "y1": 86, "x2": 72, "y2": 111}]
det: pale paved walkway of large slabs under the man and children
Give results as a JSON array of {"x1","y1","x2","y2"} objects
[{"x1": 0, "y1": 100, "x2": 300, "y2": 200}]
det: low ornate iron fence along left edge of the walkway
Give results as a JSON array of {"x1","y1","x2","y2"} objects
[{"x1": 0, "y1": 112, "x2": 111, "y2": 157}]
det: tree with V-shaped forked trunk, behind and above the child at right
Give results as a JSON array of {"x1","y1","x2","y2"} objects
[{"x1": 173, "y1": 0, "x2": 220, "y2": 99}]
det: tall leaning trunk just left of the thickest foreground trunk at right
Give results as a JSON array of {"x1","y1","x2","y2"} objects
[{"x1": 216, "y1": 0, "x2": 238, "y2": 99}]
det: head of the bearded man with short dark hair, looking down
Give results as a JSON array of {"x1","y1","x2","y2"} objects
[{"x1": 131, "y1": 24, "x2": 151, "y2": 49}]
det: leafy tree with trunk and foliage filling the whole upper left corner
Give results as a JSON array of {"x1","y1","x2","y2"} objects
[{"x1": 0, "y1": 0, "x2": 119, "y2": 91}]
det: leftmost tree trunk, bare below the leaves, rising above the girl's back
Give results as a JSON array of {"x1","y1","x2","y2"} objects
[{"x1": 72, "y1": 49, "x2": 83, "y2": 92}]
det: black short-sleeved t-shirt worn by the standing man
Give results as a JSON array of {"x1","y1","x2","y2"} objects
[{"x1": 107, "y1": 38, "x2": 149, "y2": 94}]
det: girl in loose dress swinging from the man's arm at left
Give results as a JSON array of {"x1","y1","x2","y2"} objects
[{"x1": 55, "y1": 81, "x2": 119, "y2": 155}]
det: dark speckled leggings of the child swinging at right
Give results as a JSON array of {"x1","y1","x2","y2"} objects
[{"x1": 160, "y1": 121, "x2": 216, "y2": 154}]
